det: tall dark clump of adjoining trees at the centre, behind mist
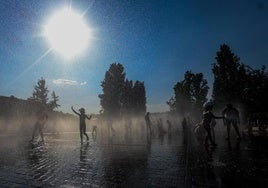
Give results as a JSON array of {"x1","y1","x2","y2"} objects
[{"x1": 99, "y1": 63, "x2": 146, "y2": 117}]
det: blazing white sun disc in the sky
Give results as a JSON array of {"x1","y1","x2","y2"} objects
[{"x1": 43, "y1": 8, "x2": 91, "y2": 59}]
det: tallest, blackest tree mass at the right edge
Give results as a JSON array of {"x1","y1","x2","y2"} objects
[{"x1": 212, "y1": 44, "x2": 268, "y2": 113}]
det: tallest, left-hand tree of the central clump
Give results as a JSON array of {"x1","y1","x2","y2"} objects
[{"x1": 99, "y1": 63, "x2": 126, "y2": 116}]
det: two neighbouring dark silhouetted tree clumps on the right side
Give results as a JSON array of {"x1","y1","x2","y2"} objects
[{"x1": 167, "y1": 44, "x2": 268, "y2": 115}]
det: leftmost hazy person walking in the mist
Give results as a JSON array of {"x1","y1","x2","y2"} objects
[{"x1": 31, "y1": 109, "x2": 48, "y2": 144}]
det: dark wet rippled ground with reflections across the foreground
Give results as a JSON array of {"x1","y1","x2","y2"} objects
[{"x1": 0, "y1": 127, "x2": 268, "y2": 188}]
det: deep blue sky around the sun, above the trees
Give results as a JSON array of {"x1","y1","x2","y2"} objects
[{"x1": 0, "y1": 0, "x2": 268, "y2": 113}]
